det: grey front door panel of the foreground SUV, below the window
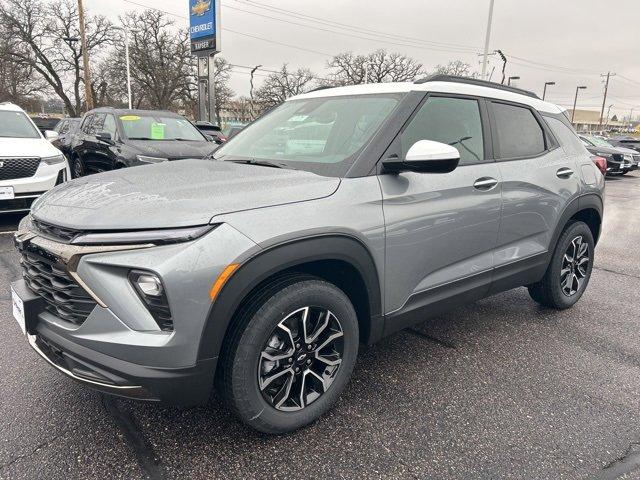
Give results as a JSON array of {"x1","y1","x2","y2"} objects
[{"x1": 379, "y1": 163, "x2": 502, "y2": 312}]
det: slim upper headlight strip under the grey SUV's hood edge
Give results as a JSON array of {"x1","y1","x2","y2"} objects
[{"x1": 71, "y1": 225, "x2": 217, "y2": 245}]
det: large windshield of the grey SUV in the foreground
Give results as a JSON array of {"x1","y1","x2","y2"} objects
[{"x1": 215, "y1": 94, "x2": 402, "y2": 176}]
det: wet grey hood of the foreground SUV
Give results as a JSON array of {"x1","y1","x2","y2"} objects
[{"x1": 32, "y1": 160, "x2": 340, "y2": 230}]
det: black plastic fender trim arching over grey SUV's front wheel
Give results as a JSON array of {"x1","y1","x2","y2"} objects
[{"x1": 198, "y1": 234, "x2": 383, "y2": 360}]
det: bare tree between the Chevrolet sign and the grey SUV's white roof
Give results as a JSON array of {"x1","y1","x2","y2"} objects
[{"x1": 256, "y1": 63, "x2": 316, "y2": 110}]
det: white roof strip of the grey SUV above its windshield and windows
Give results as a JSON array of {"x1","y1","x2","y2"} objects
[{"x1": 288, "y1": 80, "x2": 564, "y2": 113}]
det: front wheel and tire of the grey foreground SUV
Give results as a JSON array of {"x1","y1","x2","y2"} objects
[{"x1": 219, "y1": 275, "x2": 359, "y2": 434}]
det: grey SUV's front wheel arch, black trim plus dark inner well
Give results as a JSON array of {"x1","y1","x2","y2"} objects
[{"x1": 198, "y1": 234, "x2": 383, "y2": 360}]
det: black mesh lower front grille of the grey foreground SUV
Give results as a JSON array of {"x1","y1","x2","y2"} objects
[{"x1": 20, "y1": 244, "x2": 96, "y2": 325}]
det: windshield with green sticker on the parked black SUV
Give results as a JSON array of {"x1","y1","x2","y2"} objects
[{"x1": 120, "y1": 115, "x2": 207, "y2": 142}]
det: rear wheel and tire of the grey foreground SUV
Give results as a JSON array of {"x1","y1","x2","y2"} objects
[{"x1": 528, "y1": 221, "x2": 595, "y2": 310}]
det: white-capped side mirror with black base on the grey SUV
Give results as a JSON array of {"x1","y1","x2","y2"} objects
[{"x1": 382, "y1": 140, "x2": 460, "y2": 173}]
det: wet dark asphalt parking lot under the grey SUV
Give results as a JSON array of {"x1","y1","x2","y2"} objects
[{"x1": 0, "y1": 172, "x2": 640, "y2": 479}]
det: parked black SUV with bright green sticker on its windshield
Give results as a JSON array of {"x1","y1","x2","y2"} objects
[{"x1": 70, "y1": 108, "x2": 217, "y2": 178}]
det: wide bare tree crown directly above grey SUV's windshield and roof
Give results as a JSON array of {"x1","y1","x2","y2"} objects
[{"x1": 323, "y1": 50, "x2": 424, "y2": 85}]
